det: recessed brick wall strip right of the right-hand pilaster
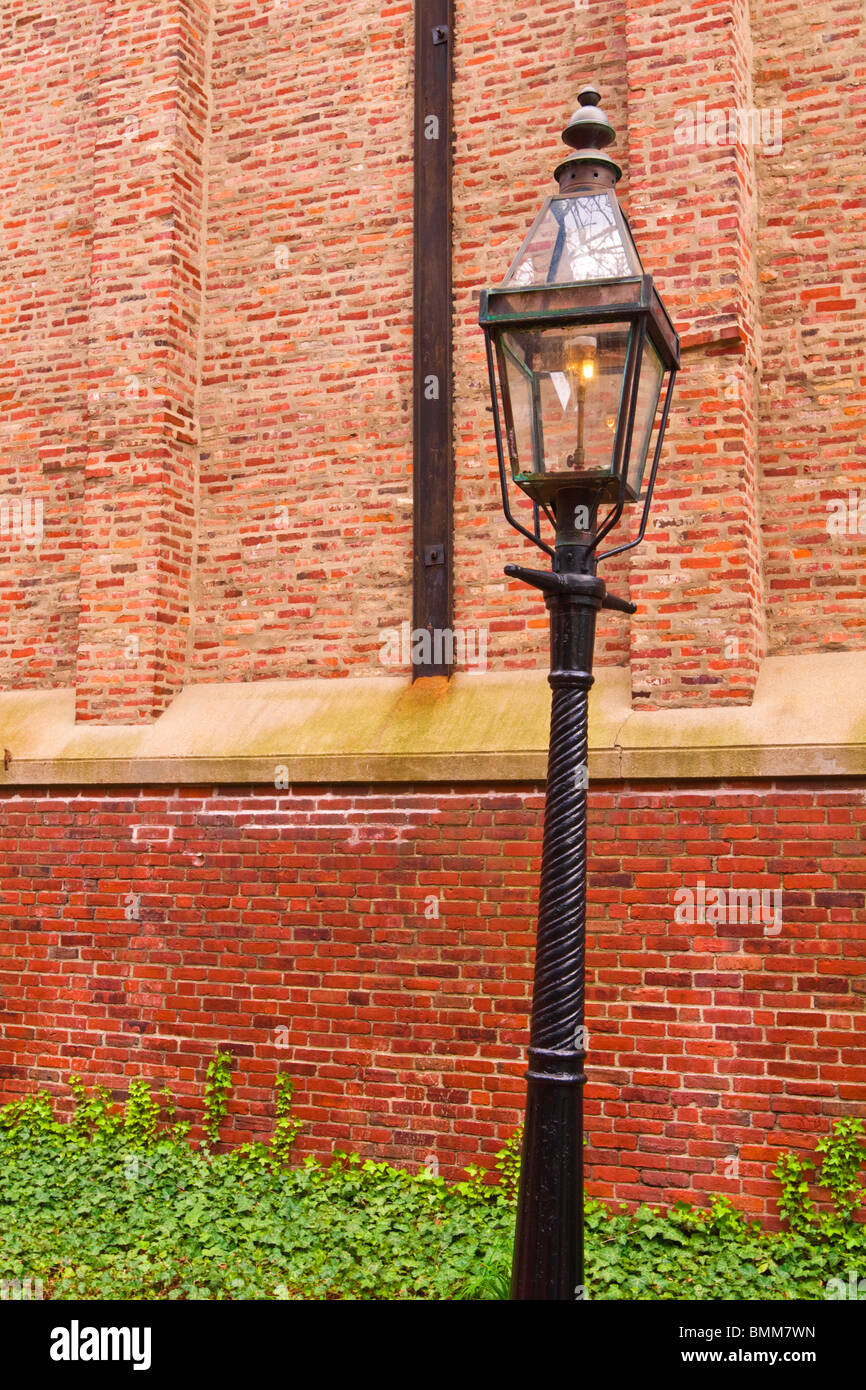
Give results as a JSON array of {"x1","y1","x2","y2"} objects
[{"x1": 755, "y1": 0, "x2": 866, "y2": 652}]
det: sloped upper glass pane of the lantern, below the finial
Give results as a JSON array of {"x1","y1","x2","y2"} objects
[{"x1": 502, "y1": 192, "x2": 642, "y2": 288}]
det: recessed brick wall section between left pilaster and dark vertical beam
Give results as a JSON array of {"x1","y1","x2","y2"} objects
[{"x1": 190, "y1": 0, "x2": 413, "y2": 680}]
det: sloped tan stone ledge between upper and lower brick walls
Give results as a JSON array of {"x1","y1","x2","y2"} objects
[{"x1": 0, "y1": 652, "x2": 866, "y2": 785}]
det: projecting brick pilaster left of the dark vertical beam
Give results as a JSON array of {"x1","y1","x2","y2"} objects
[{"x1": 76, "y1": 0, "x2": 210, "y2": 721}]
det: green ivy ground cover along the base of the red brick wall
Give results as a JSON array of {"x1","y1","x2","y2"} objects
[{"x1": 0, "y1": 1054, "x2": 866, "y2": 1300}]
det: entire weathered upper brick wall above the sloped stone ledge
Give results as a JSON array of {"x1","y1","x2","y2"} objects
[{"x1": 0, "y1": 0, "x2": 866, "y2": 721}]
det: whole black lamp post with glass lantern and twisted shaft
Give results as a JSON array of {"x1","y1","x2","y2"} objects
[{"x1": 480, "y1": 88, "x2": 680, "y2": 1300}]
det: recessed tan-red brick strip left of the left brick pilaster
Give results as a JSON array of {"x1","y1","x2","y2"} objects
[{"x1": 0, "y1": 0, "x2": 99, "y2": 688}]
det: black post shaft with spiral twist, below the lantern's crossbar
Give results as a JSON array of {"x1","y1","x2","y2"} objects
[{"x1": 512, "y1": 571, "x2": 605, "y2": 1301}]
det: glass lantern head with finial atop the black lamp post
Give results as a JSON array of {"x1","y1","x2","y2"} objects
[{"x1": 480, "y1": 89, "x2": 680, "y2": 549}]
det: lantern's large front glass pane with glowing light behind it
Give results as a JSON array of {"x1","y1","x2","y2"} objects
[{"x1": 499, "y1": 322, "x2": 633, "y2": 499}]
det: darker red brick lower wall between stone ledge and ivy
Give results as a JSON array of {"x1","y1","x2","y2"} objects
[{"x1": 0, "y1": 783, "x2": 866, "y2": 1213}]
